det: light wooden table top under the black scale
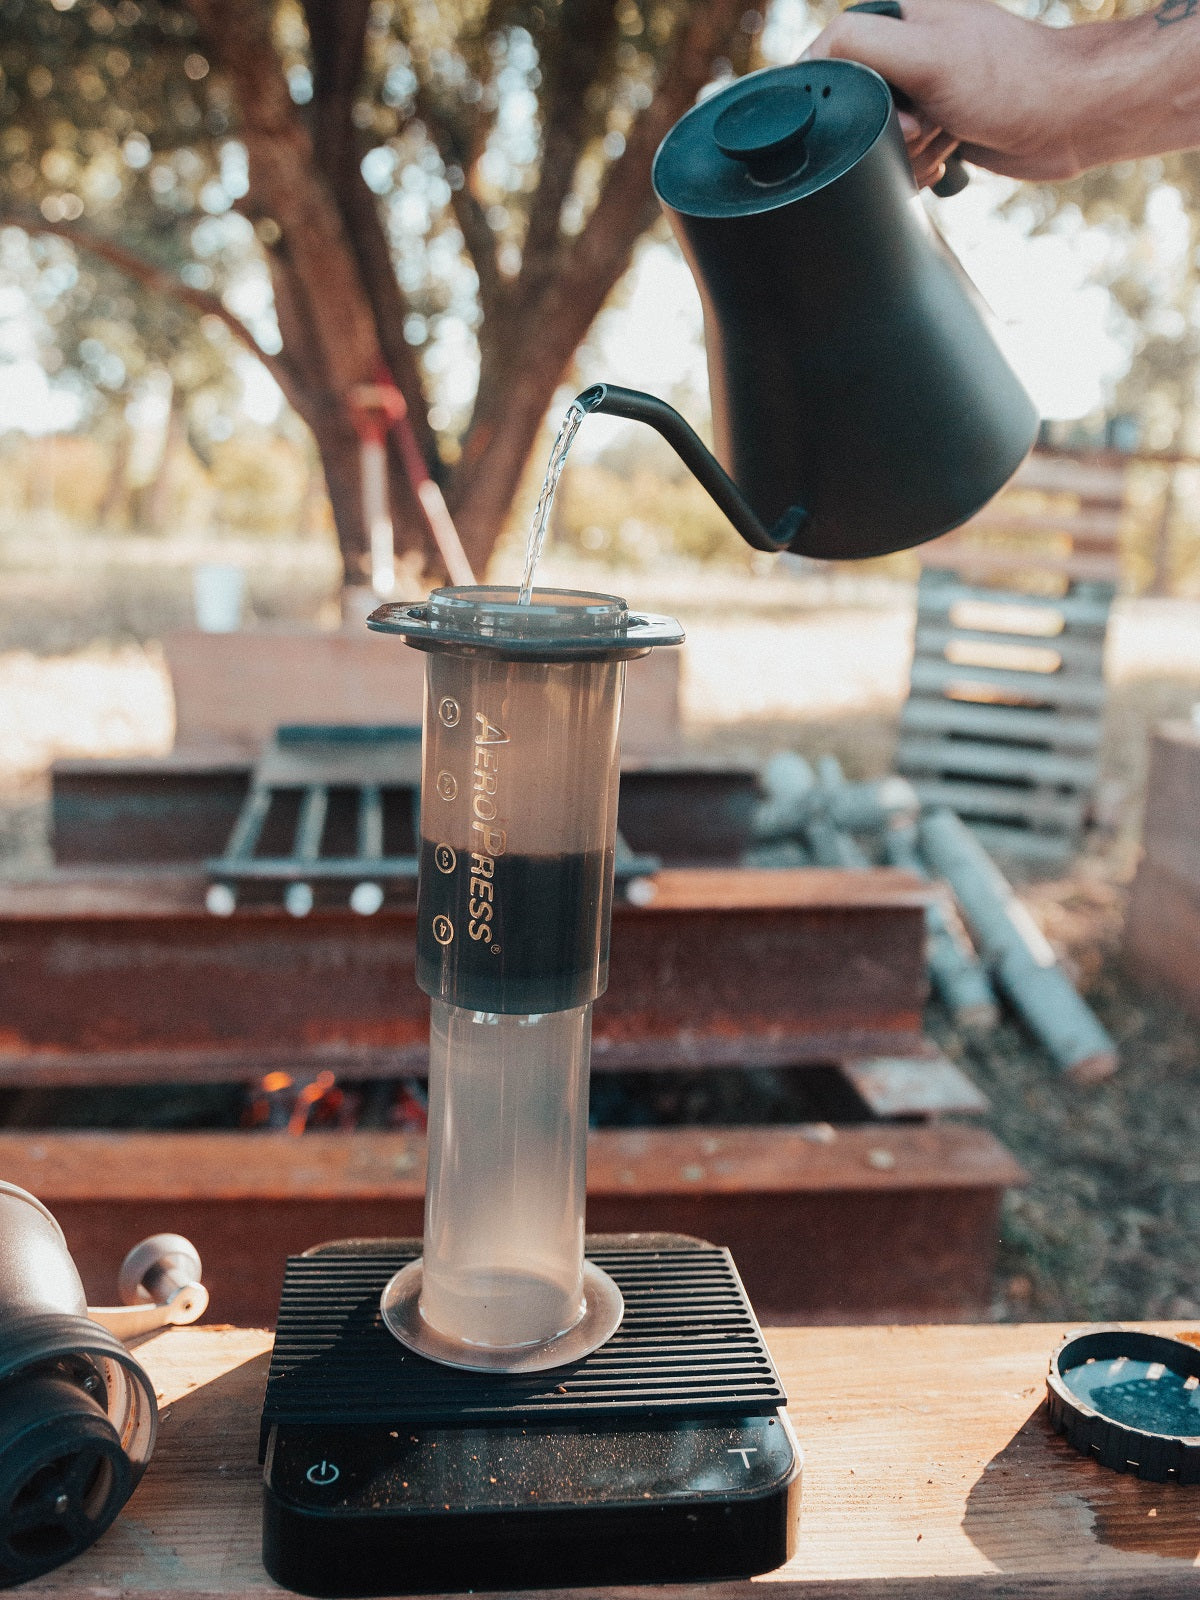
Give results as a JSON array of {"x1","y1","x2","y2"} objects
[{"x1": 22, "y1": 1325, "x2": 1200, "y2": 1600}]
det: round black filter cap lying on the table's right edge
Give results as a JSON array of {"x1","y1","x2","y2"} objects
[{"x1": 1046, "y1": 1326, "x2": 1200, "y2": 1483}]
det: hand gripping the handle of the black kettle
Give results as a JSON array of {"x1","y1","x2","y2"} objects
[{"x1": 805, "y1": 0, "x2": 1122, "y2": 186}]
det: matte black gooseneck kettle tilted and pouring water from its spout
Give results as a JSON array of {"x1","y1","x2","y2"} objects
[{"x1": 579, "y1": 36, "x2": 1038, "y2": 560}]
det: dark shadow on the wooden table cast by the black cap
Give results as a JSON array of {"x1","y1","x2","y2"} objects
[{"x1": 963, "y1": 1403, "x2": 1200, "y2": 1568}]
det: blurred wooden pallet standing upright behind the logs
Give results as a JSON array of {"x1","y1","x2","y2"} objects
[{"x1": 896, "y1": 456, "x2": 1123, "y2": 864}]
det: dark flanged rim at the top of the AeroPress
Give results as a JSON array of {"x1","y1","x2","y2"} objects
[{"x1": 366, "y1": 584, "x2": 683, "y2": 661}]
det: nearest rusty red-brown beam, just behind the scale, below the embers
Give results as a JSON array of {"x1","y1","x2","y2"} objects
[{"x1": 21, "y1": 1123, "x2": 1022, "y2": 1322}]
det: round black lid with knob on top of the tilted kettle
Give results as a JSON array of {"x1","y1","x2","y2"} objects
[{"x1": 654, "y1": 61, "x2": 891, "y2": 218}]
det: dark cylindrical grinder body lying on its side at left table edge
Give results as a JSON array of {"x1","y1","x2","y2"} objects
[{"x1": 0, "y1": 1182, "x2": 158, "y2": 1587}]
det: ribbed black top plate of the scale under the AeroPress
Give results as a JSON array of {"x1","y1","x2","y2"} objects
[{"x1": 262, "y1": 1235, "x2": 787, "y2": 1429}]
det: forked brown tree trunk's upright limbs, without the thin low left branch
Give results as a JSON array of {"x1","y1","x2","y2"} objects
[{"x1": 189, "y1": 0, "x2": 746, "y2": 582}]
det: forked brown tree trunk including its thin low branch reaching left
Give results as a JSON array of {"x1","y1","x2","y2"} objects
[{"x1": 14, "y1": 0, "x2": 762, "y2": 584}]
